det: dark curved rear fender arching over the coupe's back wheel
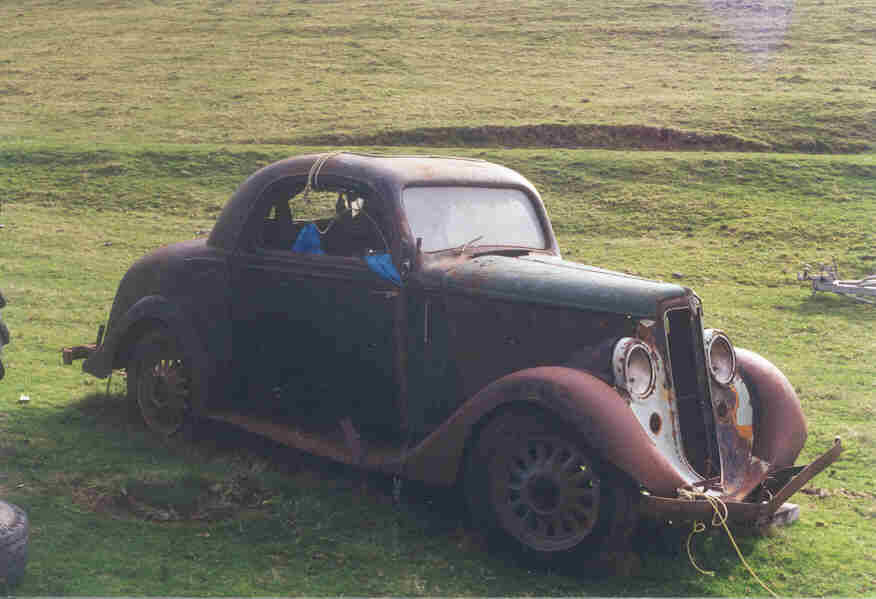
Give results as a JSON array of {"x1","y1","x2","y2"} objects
[{"x1": 82, "y1": 295, "x2": 210, "y2": 412}]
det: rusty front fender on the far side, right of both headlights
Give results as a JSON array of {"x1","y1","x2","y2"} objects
[{"x1": 736, "y1": 348, "x2": 806, "y2": 468}]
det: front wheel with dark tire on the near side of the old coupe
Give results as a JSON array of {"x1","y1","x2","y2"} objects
[{"x1": 464, "y1": 408, "x2": 630, "y2": 562}]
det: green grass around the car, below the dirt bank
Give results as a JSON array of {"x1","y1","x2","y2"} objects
[{"x1": 0, "y1": 144, "x2": 876, "y2": 595}]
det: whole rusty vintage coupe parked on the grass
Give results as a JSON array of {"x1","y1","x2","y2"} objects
[{"x1": 70, "y1": 152, "x2": 842, "y2": 554}]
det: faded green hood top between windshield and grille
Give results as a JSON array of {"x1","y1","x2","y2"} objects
[{"x1": 444, "y1": 256, "x2": 686, "y2": 317}]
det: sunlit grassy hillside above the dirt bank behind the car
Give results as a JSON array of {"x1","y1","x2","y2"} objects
[{"x1": 0, "y1": 0, "x2": 876, "y2": 152}]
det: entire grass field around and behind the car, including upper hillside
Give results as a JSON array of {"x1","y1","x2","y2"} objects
[{"x1": 0, "y1": 0, "x2": 876, "y2": 596}]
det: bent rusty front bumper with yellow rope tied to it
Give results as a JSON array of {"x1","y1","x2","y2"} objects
[{"x1": 639, "y1": 437, "x2": 843, "y2": 526}]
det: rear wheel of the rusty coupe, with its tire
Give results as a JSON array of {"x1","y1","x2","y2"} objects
[{"x1": 128, "y1": 329, "x2": 192, "y2": 437}]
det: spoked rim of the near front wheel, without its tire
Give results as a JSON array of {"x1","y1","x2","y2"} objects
[{"x1": 490, "y1": 436, "x2": 600, "y2": 551}]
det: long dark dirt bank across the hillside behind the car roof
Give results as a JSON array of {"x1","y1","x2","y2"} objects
[{"x1": 296, "y1": 124, "x2": 774, "y2": 152}]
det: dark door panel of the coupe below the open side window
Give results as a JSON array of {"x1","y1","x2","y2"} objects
[{"x1": 232, "y1": 185, "x2": 401, "y2": 430}]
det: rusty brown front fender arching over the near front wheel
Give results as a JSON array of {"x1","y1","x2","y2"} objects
[{"x1": 404, "y1": 366, "x2": 685, "y2": 497}]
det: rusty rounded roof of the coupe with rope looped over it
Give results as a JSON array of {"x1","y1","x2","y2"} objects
[{"x1": 208, "y1": 152, "x2": 540, "y2": 250}]
